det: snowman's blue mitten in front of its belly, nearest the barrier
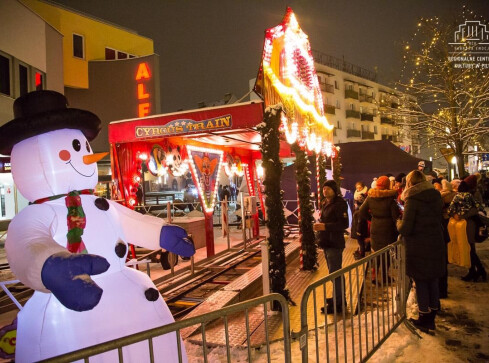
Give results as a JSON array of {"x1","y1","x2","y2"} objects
[{"x1": 41, "y1": 252, "x2": 110, "y2": 311}]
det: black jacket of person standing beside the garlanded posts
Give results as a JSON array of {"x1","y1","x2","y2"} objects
[{"x1": 319, "y1": 195, "x2": 349, "y2": 248}]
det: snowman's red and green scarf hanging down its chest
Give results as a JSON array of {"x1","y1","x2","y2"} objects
[{"x1": 32, "y1": 189, "x2": 93, "y2": 253}]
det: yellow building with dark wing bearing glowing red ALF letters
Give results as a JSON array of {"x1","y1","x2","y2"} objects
[{"x1": 20, "y1": 0, "x2": 161, "y2": 154}]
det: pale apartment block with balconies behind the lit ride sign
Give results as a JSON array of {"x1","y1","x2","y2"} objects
[{"x1": 313, "y1": 51, "x2": 420, "y2": 155}]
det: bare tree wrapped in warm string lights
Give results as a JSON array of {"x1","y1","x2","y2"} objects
[{"x1": 388, "y1": 7, "x2": 489, "y2": 176}]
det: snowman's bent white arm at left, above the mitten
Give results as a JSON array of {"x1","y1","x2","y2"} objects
[{"x1": 5, "y1": 204, "x2": 66, "y2": 292}]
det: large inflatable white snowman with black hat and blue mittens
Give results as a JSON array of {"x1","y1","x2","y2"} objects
[{"x1": 0, "y1": 91, "x2": 195, "y2": 362}]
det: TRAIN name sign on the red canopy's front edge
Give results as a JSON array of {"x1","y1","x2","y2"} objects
[{"x1": 135, "y1": 115, "x2": 233, "y2": 138}]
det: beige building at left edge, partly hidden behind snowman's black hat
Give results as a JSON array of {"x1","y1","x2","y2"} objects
[{"x1": 0, "y1": 0, "x2": 63, "y2": 222}]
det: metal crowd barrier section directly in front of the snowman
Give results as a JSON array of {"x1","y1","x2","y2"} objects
[{"x1": 41, "y1": 294, "x2": 291, "y2": 363}]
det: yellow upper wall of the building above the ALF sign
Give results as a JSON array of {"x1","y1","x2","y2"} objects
[{"x1": 21, "y1": 0, "x2": 154, "y2": 89}]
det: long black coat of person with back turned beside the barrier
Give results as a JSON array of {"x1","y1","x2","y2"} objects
[{"x1": 398, "y1": 181, "x2": 446, "y2": 280}]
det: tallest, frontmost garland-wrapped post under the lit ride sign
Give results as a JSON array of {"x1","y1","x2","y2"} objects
[{"x1": 258, "y1": 105, "x2": 290, "y2": 309}]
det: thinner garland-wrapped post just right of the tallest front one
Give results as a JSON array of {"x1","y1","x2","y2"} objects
[{"x1": 292, "y1": 143, "x2": 318, "y2": 270}]
